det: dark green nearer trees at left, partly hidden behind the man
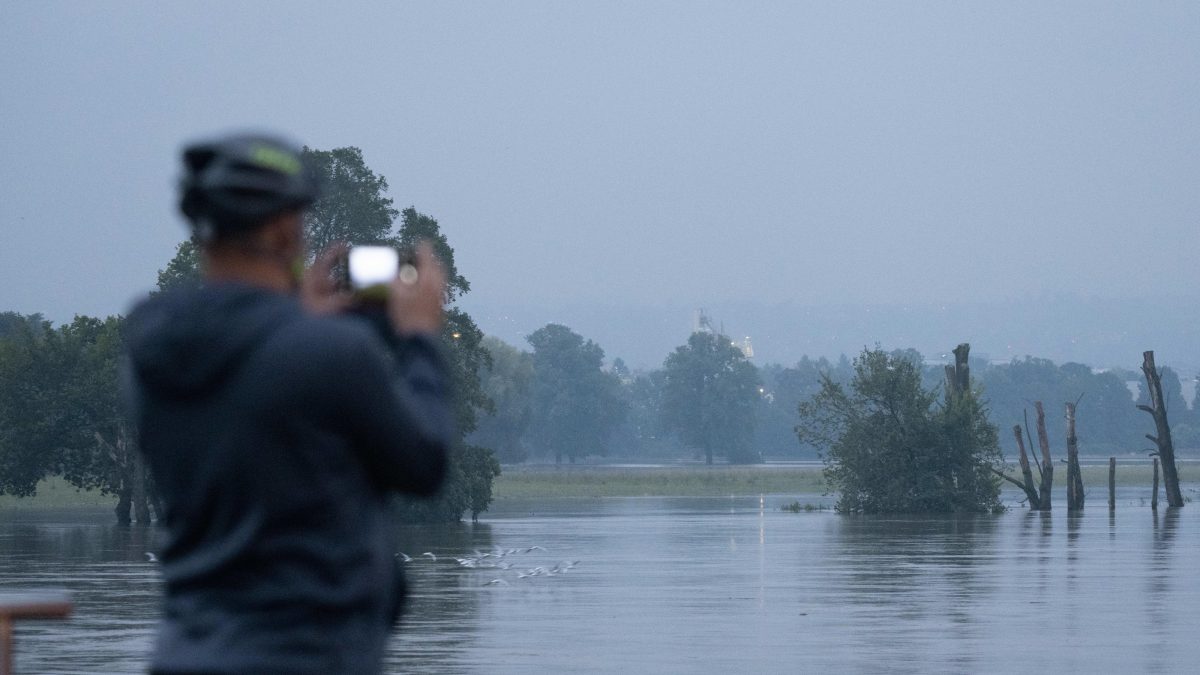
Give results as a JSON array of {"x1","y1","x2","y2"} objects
[{"x1": 0, "y1": 148, "x2": 500, "y2": 522}]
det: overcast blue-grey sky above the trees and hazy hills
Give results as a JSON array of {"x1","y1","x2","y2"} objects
[{"x1": 0, "y1": 1, "x2": 1200, "y2": 362}]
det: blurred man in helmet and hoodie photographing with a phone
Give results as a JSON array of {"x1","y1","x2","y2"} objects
[{"x1": 126, "y1": 135, "x2": 455, "y2": 673}]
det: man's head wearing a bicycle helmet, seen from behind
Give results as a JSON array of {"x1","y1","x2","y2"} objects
[{"x1": 179, "y1": 135, "x2": 318, "y2": 284}]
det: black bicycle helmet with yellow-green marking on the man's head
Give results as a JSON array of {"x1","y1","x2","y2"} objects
[{"x1": 179, "y1": 133, "x2": 319, "y2": 240}]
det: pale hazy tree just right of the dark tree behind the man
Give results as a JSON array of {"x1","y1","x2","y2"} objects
[{"x1": 469, "y1": 338, "x2": 533, "y2": 464}]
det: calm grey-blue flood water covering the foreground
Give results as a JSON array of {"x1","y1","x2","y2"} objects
[{"x1": 0, "y1": 490, "x2": 1200, "y2": 674}]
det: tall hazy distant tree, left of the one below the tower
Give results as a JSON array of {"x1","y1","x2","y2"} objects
[{"x1": 527, "y1": 323, "x2": 626, "y2": 464}]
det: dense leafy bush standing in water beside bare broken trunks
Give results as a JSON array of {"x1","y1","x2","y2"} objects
[{"x1": 797, "y1": 350, "x2": 1003, "y2": 513}]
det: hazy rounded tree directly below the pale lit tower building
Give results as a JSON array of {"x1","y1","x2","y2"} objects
[{"x1": 662, "y1": 331, "x2": 762, "y2": 464}]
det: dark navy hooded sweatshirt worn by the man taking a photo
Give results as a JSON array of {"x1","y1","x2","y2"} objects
[{"x1": 127, "y1": 285, "x2": 454, "y2": 673}]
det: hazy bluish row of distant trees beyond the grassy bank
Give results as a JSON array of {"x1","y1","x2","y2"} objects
[{"x1": 472, "y1": 324, "x2": 1200, "y2": 464}]
